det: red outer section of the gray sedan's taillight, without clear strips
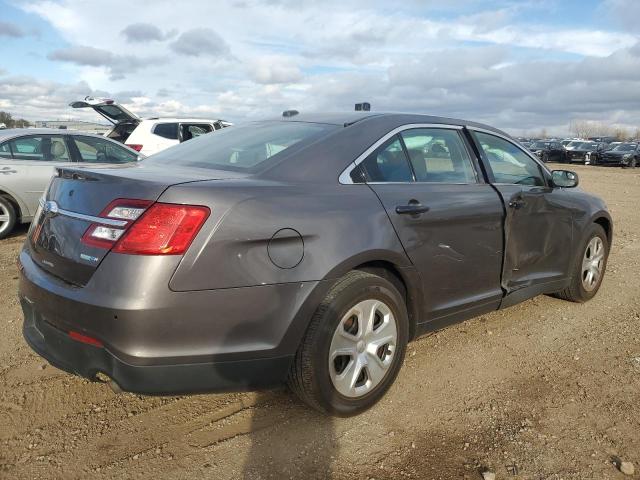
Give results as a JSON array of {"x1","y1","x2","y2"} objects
[{"x1": 113, "y1": 203, "x2": 210, "y2": 255}]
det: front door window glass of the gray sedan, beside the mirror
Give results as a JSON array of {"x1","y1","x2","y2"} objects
[{"x1": 475, "y1": 132, "x2": 545, "y2": 186}]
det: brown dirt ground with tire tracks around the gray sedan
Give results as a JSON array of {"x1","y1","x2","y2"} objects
[{"x1": 0, "y1": 166, "x2": 640, "y2": 480}]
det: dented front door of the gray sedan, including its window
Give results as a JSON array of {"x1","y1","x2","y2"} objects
[{"x1": 472, "y1": 130, "x2": 573, "y2": 293}]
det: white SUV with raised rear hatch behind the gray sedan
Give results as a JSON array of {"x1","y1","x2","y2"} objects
[{"x1": 69, "y1": 97, "x2": 233, "y2": 156}]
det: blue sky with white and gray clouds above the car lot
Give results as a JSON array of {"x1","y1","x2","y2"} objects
[{"x1": 0, "y1": 0, "x2": 640, "y2": 134}]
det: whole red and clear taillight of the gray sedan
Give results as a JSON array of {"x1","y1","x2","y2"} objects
[{"x1": 82, "y1": 199, "x2": 211, "y2": 255}]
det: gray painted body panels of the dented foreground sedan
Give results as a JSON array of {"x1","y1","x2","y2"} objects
[{"x1": 20, "y1": 112, "x2": 611, "y2": 394}]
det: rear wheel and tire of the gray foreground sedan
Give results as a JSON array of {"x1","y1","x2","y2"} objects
[{"x1": 287, "y1": 270, "x2": 409, "y2": 417}]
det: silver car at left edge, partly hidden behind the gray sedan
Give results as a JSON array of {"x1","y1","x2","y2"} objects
[{"x1": 0, "y1": 129, "x2": 143, "y2": 238}]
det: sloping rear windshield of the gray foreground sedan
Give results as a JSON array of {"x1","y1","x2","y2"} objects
[{"x1": 145, "y1": 122, "x2": 338, "y2": 172}]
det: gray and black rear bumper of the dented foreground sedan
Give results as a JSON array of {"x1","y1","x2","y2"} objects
[{"x1": 19, "y1": 251, "x2": 331, "y2": 394}]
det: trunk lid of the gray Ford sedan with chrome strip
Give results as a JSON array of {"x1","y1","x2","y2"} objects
[{"x1": 26, "y1": 162, "x2": 245, "y2": 286}]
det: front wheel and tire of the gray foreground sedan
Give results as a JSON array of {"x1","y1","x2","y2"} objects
[{"x1": 554, "y1": 223, "x2": 609, "y2": 303}]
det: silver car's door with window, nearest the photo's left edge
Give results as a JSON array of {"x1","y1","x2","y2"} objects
[{"x1": 0, "y1": 135, "x2": 73, "y2": 216}]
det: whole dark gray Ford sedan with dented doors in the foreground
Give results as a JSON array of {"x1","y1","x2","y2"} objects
[{"x1": 19, "y1": 112, "x2": 612, "y2": 416}]
